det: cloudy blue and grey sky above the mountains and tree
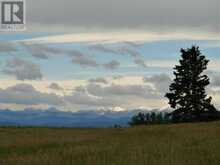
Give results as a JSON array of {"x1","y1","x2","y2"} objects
[{"x1": 0, "y1": 0, "x2": 220, "y2": 111}]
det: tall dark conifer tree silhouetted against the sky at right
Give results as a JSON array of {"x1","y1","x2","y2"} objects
[{"x1": 165, "y1": 46, "x2": 219, "y2": 122}]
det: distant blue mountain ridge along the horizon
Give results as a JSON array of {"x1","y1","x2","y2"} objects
[{"x1": 0, "y1": 108, "x2": 170, "y2": 127}]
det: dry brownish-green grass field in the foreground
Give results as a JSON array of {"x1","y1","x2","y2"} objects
[{"x1": 0, "y1": 122, "x2": 220, "y2": 165}]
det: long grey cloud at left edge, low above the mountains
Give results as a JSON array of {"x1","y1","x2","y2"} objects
[{"x1": 0, "y1": 84, "x2": 63, "y2": 105}]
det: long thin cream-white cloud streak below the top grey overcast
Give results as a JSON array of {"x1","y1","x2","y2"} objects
[{"x1": 21, "y1": 30, "x2": 219, "y2": 44}]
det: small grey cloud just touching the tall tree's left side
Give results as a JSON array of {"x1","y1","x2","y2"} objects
[{"x1": 143, "y1": 74, "x2": 172, "y2": 94}]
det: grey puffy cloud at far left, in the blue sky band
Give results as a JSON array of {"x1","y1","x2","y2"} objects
[{"x1": 3, "y1": 58, "x2": 43, "y2": 80}]
